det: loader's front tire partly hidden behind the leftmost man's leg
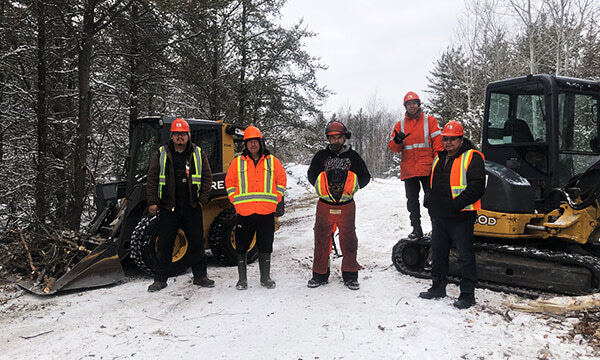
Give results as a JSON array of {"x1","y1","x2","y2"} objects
[{"x1": 131, "y1": 215, "x2": 189, "y2": 276}]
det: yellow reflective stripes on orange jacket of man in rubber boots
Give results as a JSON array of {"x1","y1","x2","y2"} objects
[{"x1": 232, "y1": 155, "x2": 281, "y2": 205}]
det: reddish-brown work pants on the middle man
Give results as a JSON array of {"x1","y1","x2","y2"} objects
[{"x1": 313, "y1": 201, "x2": 361, "y2": 274}]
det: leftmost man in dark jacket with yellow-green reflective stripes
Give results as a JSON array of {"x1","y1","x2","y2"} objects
[{"x1": 146, "y1": 118, "x2": 215, "y2": 292}]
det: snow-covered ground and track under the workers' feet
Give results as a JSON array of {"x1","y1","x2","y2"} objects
[{"x1": 0, "y1": 165, "x2": 599, "y2": 359}]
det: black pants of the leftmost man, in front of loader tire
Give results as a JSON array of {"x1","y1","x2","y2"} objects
[{"x1": 154, "y1": 206, "x2": 206, "y2": 281}]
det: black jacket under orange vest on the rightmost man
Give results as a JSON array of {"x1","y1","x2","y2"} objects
[{"x1": 424, "y1": 138, "x2": 485, "y2": 221}]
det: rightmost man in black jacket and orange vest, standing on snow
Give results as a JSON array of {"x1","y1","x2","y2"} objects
[{"x1": 419, "y1": 120, "x2": 485, "y2": 309}]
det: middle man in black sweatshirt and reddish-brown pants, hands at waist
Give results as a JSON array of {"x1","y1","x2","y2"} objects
[{"x1": 307, "y1": 120, "x2": 371, "y2": 290}]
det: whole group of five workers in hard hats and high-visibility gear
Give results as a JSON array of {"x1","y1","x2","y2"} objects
[{"x1": 147, "y1": 91, "x2": 485, "y2": 309}]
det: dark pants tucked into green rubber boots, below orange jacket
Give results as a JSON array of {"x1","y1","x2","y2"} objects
[{"x1": 235, "y1": 213, "x2": 275, "y2": 254}]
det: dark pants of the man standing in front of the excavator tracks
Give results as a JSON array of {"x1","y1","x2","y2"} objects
[{"x1": 431, "y1": 219, "x2": 477, "y2": 294}]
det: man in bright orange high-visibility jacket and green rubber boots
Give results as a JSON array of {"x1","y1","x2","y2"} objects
[{"x1": 225, "y1": 125, "x2": 287, "y2": 290}]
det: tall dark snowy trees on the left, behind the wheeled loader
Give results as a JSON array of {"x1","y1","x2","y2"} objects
[{"x1": 0, "y1": 0, "x2": 328, "y2": 234}]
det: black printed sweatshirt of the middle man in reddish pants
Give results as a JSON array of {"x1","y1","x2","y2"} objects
[{"x1": 307, "y1": 144, "x2": 371, "y2": 189}]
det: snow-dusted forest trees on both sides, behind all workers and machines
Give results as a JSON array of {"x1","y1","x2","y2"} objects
[{"x1": 0, "y1": 0, "x2": 600, "y2": 237}]
